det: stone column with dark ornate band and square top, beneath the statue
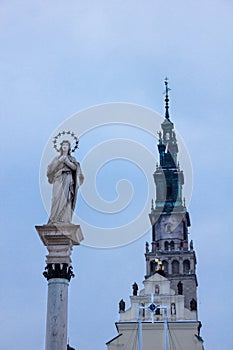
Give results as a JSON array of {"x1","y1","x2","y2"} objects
[{"x1": 36, "y1": 224, "x2": 83, "y2": 350}]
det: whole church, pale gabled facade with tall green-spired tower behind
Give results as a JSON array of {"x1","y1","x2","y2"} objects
[{"x1": 107, "y1": 79, "x2": 204, "y2": 350}]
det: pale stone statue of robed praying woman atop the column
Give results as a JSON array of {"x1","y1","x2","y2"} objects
[{"x1": 47, "y1": 140, "x2": 84, "y2": 224}]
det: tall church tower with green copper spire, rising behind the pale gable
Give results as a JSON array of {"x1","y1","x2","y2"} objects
[{"x1": 145, "y1": 81, "x2": 197, "y2": 311}]
